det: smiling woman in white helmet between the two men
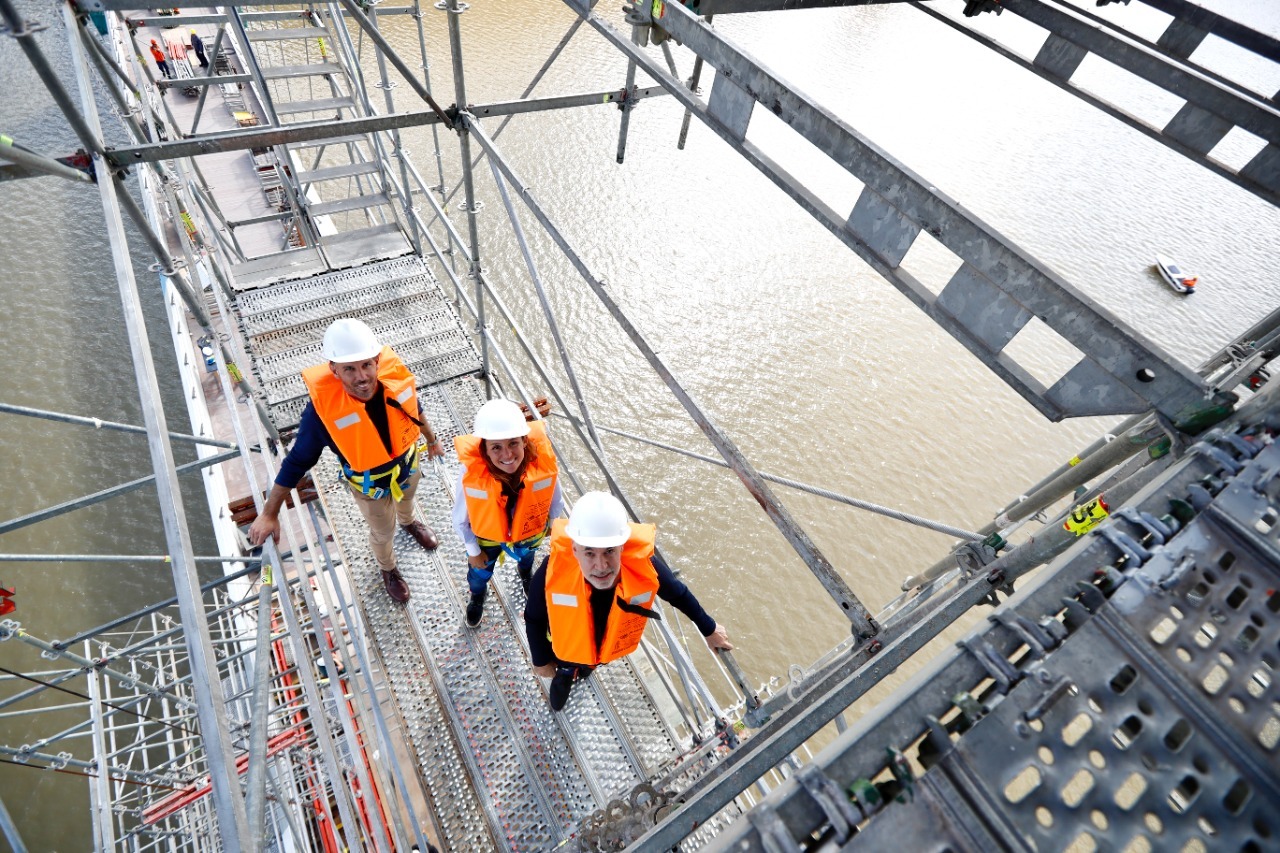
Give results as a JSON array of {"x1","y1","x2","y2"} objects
[{"x1": 453, "y1": 400, "x2": 564, "y2": 628}]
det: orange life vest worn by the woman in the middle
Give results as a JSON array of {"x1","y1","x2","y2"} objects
[{"x1": 453, "y1": 420, "x2": 559, "y2": 543}]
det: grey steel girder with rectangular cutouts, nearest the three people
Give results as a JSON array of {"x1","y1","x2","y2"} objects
[{"x1": 578, "y1": 0, "x2": 1208, "y2": 421}]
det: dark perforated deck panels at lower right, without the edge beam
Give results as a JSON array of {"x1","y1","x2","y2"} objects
[{"x1": 849, "y1": 439, "x2": 1280, "y2": 850}]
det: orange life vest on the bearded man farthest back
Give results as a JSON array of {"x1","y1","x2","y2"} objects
[{"x1": 302, "y1": 347, "x2": 422, "y2": 473}]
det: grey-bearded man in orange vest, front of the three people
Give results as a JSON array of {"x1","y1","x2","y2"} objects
[{"x1": 525, "y1": 492, "x2": 733, "y2": 711}]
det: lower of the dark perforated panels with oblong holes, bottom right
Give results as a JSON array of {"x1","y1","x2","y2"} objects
[{"x1": 945, "y1": 619, "x2": 1280, "y2": 850}]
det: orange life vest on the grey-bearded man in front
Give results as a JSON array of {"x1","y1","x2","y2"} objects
[{"x1": 547, "y1": 519, "x2": 658, "y2": 666}]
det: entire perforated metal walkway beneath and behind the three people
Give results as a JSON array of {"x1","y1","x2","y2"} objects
[{"x1": 237, "y1": 259, "x2": 701, "y2": 850}]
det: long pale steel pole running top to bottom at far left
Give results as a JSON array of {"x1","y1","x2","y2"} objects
[{"x1": 57, "y1": 0, "x2": 246, "y2": 852}]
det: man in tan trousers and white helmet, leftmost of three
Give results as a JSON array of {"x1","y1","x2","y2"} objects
[{"x1": 248, "y1": 319, "x2": 444, "y2": 603}]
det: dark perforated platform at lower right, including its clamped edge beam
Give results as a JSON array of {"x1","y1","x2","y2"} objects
[{"x1": 716, "y1": 401, "x2": 1280, "y2": 853}]
